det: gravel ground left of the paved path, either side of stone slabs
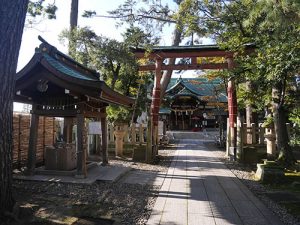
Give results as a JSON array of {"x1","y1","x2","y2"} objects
[{"x1": 11, "y1": 146, "x2": 175, "y2": 225}]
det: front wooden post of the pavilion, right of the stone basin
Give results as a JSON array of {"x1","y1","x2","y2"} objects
[{"x1": 76, "y1": 113, "x2": 87, "y2": 178}]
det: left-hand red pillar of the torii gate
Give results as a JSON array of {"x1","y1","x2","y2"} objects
[{"x1": 151, "y1": 58, "x2": 162, "y2": 158}]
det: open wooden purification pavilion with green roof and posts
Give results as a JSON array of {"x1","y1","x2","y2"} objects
[{"x1": 14, "y1": 37, "x2": 134, "y2": 177}]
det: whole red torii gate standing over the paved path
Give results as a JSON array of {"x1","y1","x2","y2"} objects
[{"x1": 133, "y1": 45, "x2": 246, "y2": 159}]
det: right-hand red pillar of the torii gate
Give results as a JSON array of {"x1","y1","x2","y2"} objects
[{"x1": 227, "y1": 57, "x2": 237, "y2": 161}]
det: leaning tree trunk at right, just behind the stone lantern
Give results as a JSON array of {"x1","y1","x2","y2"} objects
[{"x1": 272, "y1": 85, "x2": 296, "y2": 166}]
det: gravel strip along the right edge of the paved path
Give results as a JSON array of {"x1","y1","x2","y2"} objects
[{"x1": 208, "y1": 144, "x2": 300, "y2": 225}]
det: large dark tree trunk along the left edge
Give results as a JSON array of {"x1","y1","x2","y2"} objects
[{"x1": 0, "y1": 0, "x2": 28, "y2": 218}]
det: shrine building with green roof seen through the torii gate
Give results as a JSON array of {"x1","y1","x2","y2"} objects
[{"x1": 162, "y1": 77, "x2": 227, "y2": 131}]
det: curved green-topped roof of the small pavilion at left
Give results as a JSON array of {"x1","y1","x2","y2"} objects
[{"x1": 15, "y1": 37, "x2": 134, "y2": 106}]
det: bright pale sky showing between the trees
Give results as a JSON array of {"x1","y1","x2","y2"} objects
[{"x1": 14, "y1": 0, "x2": 213, "y2": 110}]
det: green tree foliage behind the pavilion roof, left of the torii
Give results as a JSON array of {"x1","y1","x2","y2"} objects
[{"x1": 60, "y1": 27, "x2": 155, "y2": 125}]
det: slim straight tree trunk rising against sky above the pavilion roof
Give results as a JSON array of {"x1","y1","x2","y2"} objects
[{"x1": 69, "y1": 0, "x2": 79, "y2": 56}]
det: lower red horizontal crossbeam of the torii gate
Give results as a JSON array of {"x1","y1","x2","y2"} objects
[{"x1": 139, "y1": 63, "x2": 228, "y2": 71}]
